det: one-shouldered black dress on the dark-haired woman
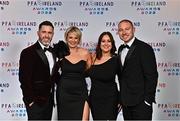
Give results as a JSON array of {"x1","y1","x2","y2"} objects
[{"x1": 89, "y1": 56, "x2": 119, "y2": 120}]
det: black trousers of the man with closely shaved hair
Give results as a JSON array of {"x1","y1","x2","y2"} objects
[{"x1": 122, "y1": 101, "x2": 153, "y2": 120}]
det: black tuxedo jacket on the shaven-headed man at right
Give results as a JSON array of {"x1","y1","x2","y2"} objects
[{"x1": 118, "y1": 38, "x2": 158, "y2": 106}]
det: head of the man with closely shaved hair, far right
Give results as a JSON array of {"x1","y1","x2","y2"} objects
[{"x1": 118, "y1": 21, "x2": 135, "y2": 43}]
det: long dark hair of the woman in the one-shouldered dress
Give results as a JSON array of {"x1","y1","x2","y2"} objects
[{"x1": 96, "y1": 31, "x2": 116, "y2": 59}]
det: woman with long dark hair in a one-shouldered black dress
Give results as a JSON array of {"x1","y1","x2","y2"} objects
[{"x1": 89, "y1": 32, "x2": 120, "y2": 120}]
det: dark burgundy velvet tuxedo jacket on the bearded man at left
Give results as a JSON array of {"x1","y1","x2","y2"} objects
[{"x1": 19, "y1": 42, "x2": 55, "y2": 104}]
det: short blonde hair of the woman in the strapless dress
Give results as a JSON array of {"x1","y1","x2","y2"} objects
[{"x1": 64, "y1": 26, "x2": 82, "y2": 43}]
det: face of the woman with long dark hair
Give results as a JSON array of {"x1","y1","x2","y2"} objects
[{"x1": 100, "y1": 35, "x2": 112, "y2": 53}]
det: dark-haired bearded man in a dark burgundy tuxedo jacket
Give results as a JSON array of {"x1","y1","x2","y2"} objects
[{"x1": 19, "y1": 21, "x2": 55, "y2": 120}]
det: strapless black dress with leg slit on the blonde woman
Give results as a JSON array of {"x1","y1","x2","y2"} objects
[{"x1": 57, "y1": 58, "x2": 88, "y2": 120}]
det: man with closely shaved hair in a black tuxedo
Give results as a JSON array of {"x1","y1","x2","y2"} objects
[{"x1": 118, "y1": 19, "x2": 158, "y2": 120}]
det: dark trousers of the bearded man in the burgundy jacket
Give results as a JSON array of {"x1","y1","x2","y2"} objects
[{"x1": 26, "y1": 97, "x2": 53, "y2": 120}]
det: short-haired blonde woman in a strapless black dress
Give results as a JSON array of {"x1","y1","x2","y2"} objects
[{"x1": 57, "y1": 26, "x2": 91, "y2": 120}]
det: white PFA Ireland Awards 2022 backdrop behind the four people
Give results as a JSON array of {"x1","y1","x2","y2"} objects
[{"x1": 0, "y1": 0, "x2": 180, "y2": 120}]
